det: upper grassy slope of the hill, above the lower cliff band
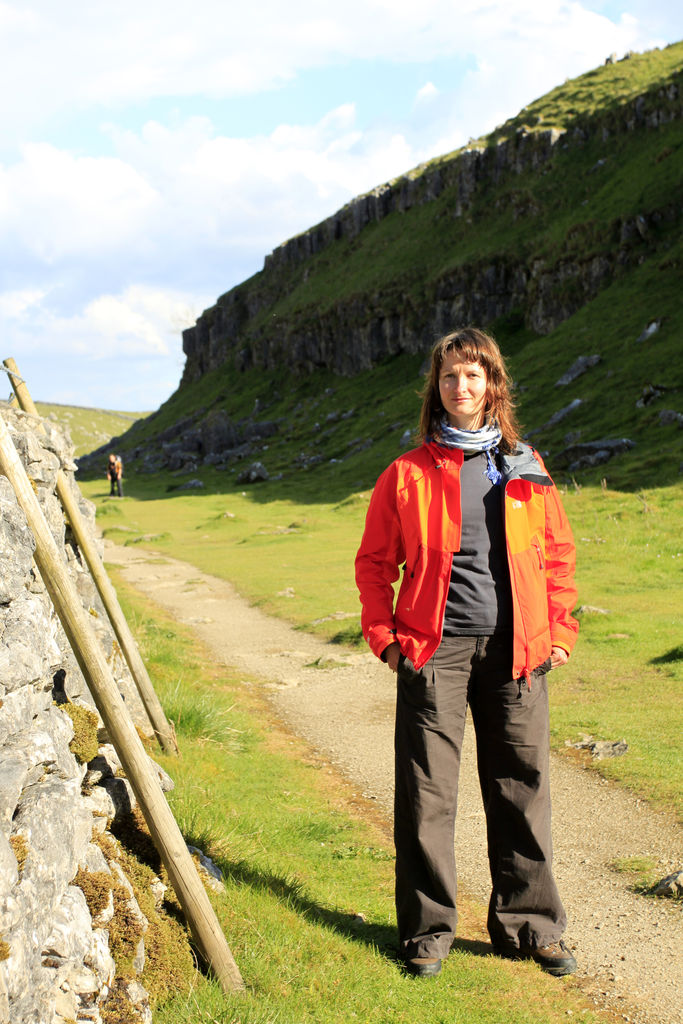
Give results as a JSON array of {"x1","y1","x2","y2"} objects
[{"x1": 189, "y1": 44, "x2": 683, "y2": 349}]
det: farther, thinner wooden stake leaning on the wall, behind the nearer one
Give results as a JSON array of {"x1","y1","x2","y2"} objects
[{"x1": 4, "y1": 359, "x2": 178, "y2": 754}]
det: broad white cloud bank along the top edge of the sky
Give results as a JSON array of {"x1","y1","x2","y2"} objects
[{"x1": 0, "y1": 0, "x2": 653, "y2": 142}]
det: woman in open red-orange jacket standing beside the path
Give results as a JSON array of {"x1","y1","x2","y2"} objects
[{"x1": 356, "y1": 328, "x2": 579, "y2": 976}]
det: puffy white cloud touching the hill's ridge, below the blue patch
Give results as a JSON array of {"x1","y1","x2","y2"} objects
[{"x1": 101, "y1": 103, "x2": 422, "y2": 256}]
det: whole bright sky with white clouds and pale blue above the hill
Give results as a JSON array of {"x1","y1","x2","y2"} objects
[{"x1": 0, "y1": 0, "x2": 683, "y2": 412}]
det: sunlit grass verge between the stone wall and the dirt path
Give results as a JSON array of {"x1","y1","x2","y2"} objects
[{"x1": 109, "y1": 578, "x2": 602, "y2": 1024}]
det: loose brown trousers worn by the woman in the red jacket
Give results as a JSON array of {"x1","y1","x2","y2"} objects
[{"x1": 394, "y1": 634, "x2": 566, "y2": 959}]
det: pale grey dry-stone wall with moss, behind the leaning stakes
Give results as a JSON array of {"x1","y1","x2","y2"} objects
[{"x1": 0, "y1": 404, "x2": 170, "y2": 1024}]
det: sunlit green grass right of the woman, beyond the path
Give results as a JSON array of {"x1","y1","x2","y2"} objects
[{"x1": 540, "y1": 484, "x2": 683, "y2": 820}]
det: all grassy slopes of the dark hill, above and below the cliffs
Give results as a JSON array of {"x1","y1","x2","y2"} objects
[{"x1": 97, "y1": 43, "x2": 683, "y2": 501}]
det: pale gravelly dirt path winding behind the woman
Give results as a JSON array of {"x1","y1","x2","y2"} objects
[{"x1": 105, "y1": 543, "x2": 683, "y2": 1024}]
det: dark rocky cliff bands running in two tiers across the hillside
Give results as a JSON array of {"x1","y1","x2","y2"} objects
[{"x1": 183, "y1": 64, "x2": 682, "y2": 382}]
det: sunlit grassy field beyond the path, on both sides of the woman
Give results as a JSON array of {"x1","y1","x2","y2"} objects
[{"x1": 83, "y1": 474, "x2": 683, "y2": 819}]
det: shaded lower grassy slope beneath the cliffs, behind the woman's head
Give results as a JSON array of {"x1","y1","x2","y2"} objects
[{"x1": 87, "y1": 243, "x2": 683, "y2": 493}]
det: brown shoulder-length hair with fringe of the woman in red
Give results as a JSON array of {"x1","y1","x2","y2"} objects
[{"x1": 418, "y1": 327, "x2": 520, "y2": 452}]
